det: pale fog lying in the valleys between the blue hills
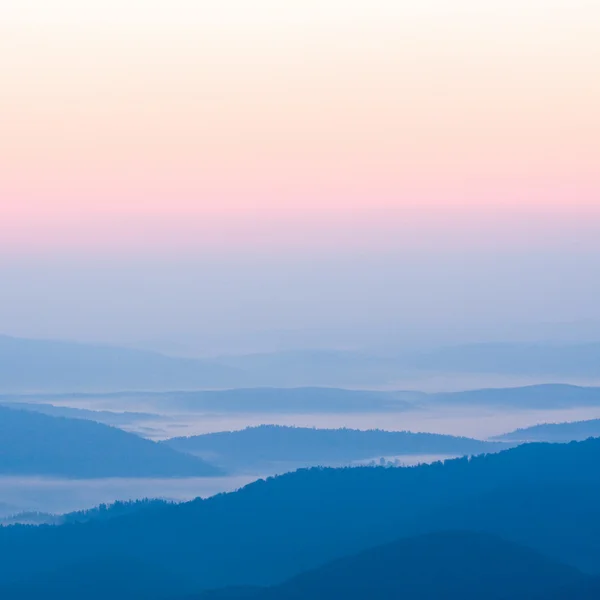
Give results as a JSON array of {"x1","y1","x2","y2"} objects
[{"x1": 0, "y1": 390, "x2": 600, "y2": 517}]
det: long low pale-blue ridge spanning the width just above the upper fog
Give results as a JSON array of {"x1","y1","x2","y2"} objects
[{"x1": 11, "y1": 384, "x2": 600, "y2": 414}]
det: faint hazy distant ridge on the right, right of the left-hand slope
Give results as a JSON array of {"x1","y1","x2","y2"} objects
[{"x1": 209, "y1": 342, "x2": 600, "y2": 386}]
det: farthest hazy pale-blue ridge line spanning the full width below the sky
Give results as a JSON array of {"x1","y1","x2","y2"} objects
[{"x1": 0, "y1": 336, "x2": 600, "y2": 392}]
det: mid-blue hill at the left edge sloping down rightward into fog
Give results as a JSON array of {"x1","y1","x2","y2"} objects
[{"x1": 0, "y1": 406, "x2": 221, "y2": 478}]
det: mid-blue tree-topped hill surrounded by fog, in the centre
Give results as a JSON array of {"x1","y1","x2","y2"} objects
[{"x1": 163, "y1": 425, "x2": 506, "y2": 472}]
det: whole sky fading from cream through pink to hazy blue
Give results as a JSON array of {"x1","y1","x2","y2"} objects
[{"x1": 0, "y1": 0, "x2": 600, "y2": 350}]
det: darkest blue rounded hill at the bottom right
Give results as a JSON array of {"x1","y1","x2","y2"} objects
[{"x1": 192, "y1": 532, "x2": 593, "y2": 600}]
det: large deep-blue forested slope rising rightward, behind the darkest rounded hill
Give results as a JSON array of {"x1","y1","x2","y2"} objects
[{"x1": 0, "y1": 439, "x2": 600, "y2": 598}]
